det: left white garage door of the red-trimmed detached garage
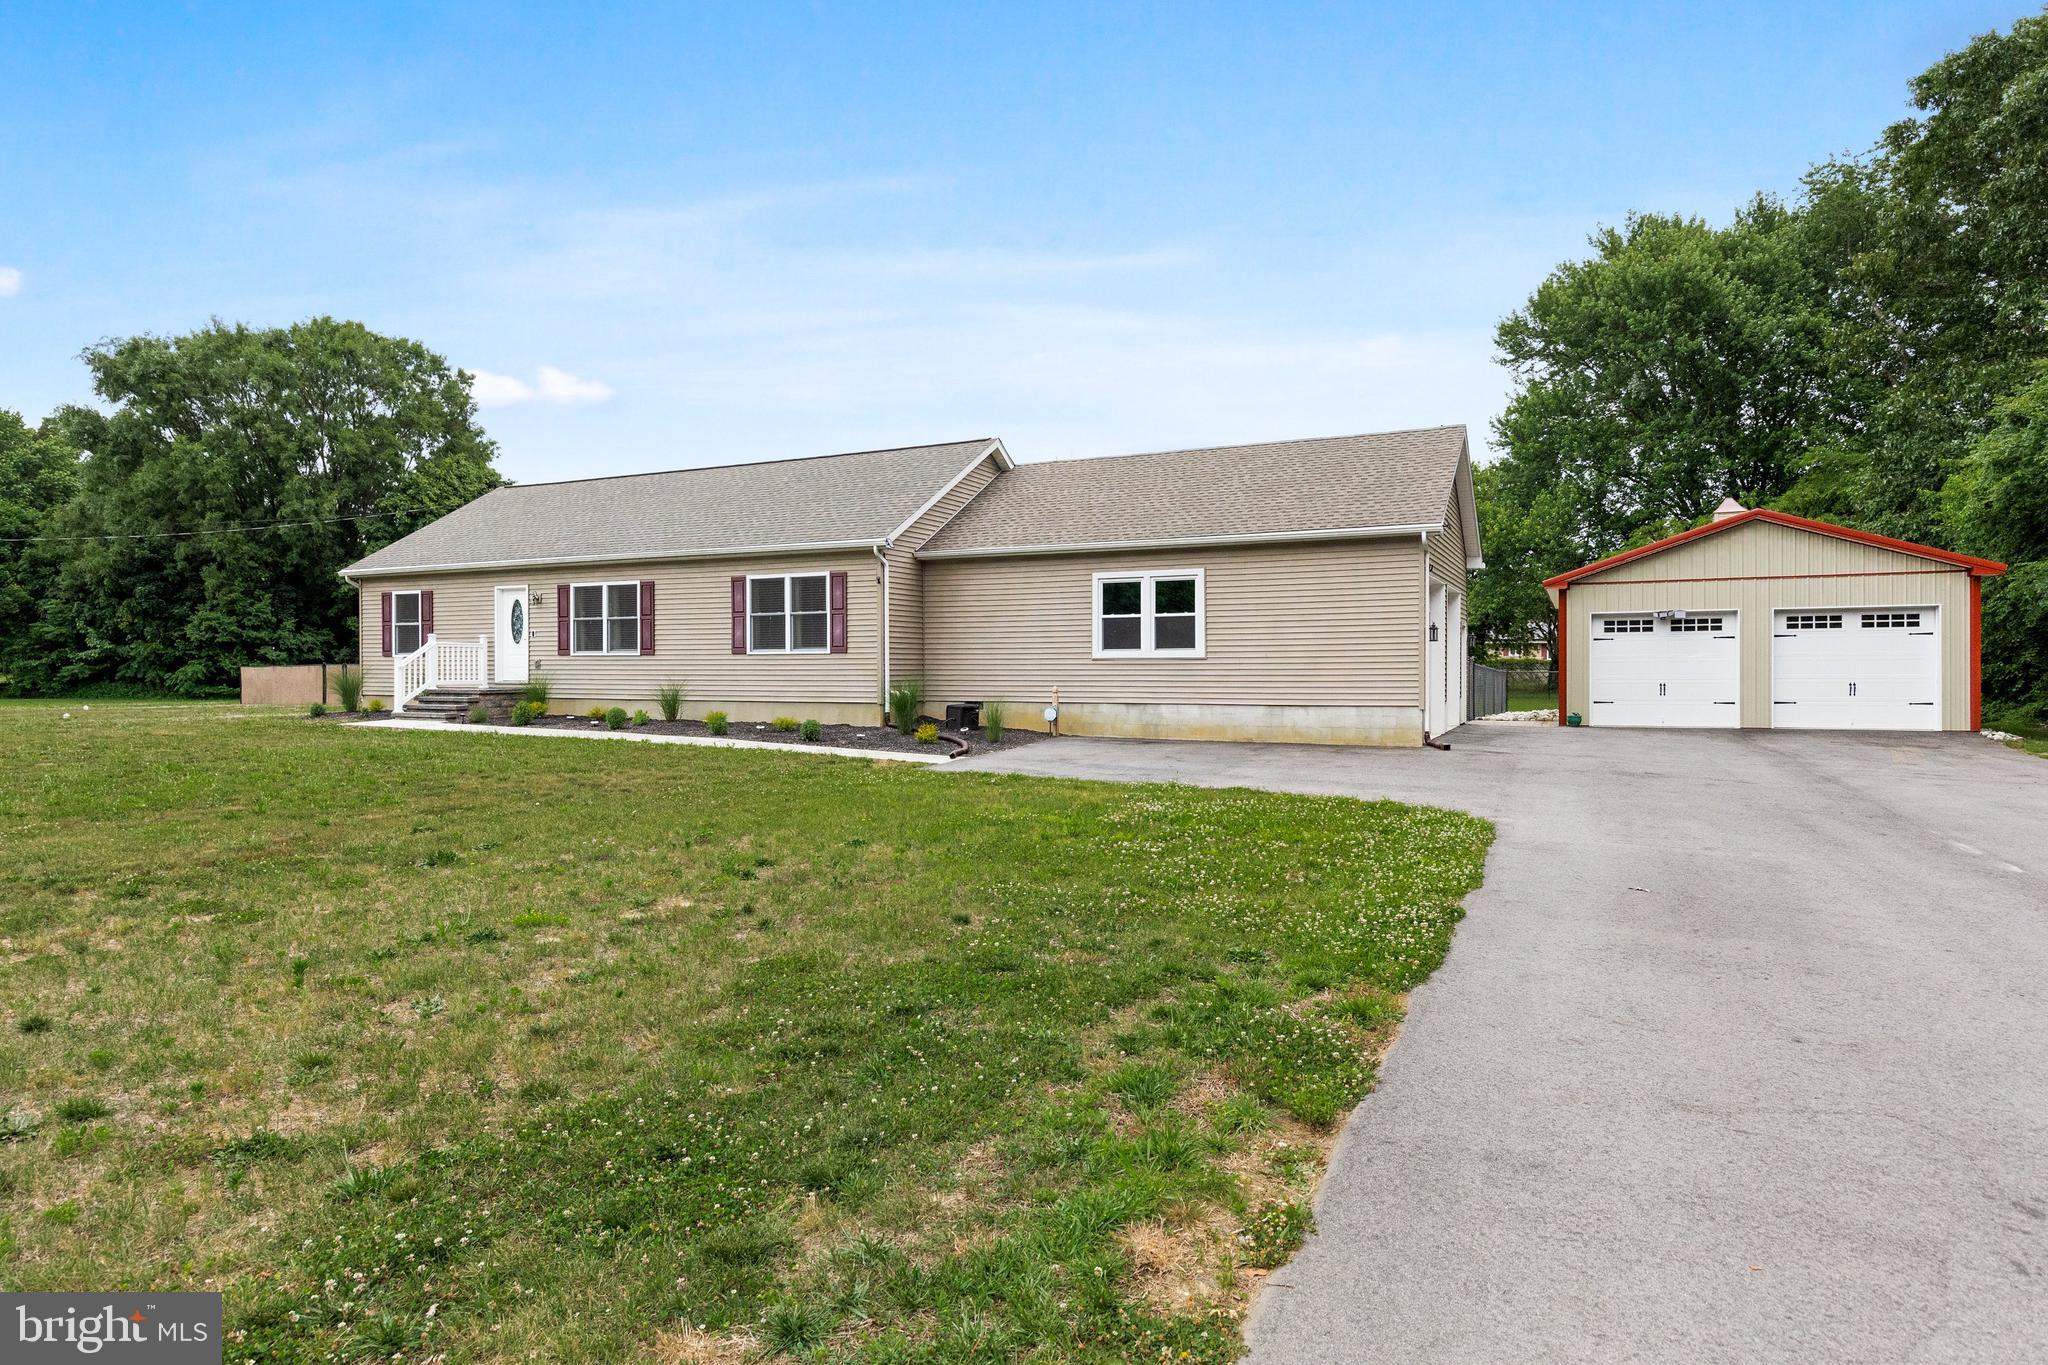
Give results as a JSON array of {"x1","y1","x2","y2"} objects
[{"x1": 1585, "y1": 612, "x2": 1743, "y2": 729}]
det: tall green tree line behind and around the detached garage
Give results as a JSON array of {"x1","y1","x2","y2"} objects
[{"x1": 1470, "y1": 12, "x2": 2048, "y2": 708}]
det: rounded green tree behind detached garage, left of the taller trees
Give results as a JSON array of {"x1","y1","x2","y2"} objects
[{"x1": 1473, "y1": 196, "x2": 1833, "y2": 654}]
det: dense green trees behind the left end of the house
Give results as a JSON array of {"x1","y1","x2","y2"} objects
[{"x1": 0, "y1": 317, "x2": 502, "y2": 696}]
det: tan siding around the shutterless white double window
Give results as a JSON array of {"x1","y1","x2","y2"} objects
[{"x1": 924, "y1": 538, "x2": 1423, "y2": 708}]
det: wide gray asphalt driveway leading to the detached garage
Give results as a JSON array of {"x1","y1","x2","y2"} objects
[{"x1": 961, "y1": 724, "x2": 2048, "y2": 1363}]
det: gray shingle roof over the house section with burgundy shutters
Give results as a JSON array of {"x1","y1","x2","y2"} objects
[{"x1": 344, "y1": 438, "x2": 995, "y2": 577}]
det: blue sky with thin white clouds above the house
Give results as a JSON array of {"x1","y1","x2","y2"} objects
[{"x1": 0, "y1": 0, "x2": 2025, "y2": 481}]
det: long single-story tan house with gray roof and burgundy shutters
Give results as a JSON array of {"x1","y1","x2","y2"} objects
[{"x1": 344, "y1": 426, "x2": 1479, "y2": 745}]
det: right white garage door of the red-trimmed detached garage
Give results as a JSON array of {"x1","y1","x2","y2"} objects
[{"x1": 1772, "y1": 606, "x2": 1942, "y2": 731}]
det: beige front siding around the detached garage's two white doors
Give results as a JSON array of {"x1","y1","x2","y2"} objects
[{"x1": 1565, "y1": 522, "x2": 1970, "y2": 731}]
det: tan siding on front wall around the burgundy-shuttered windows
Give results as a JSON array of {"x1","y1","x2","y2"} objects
[{"x1": 362, "y1": 551, "x2": 881, "y2": 714}]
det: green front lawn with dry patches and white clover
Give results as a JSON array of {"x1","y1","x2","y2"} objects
[{"x1": 0, "y1": 702, "x2": 1491, "y2": 1361}]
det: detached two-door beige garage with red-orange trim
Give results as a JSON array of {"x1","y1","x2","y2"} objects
[{"x1": 1544, "y1": 499, "x2": 2005, "y2": 731}]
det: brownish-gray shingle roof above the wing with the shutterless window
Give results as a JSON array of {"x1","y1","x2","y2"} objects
[{"x1": 920, "y1": 426, "x2": 1464, "y2": 557}]
